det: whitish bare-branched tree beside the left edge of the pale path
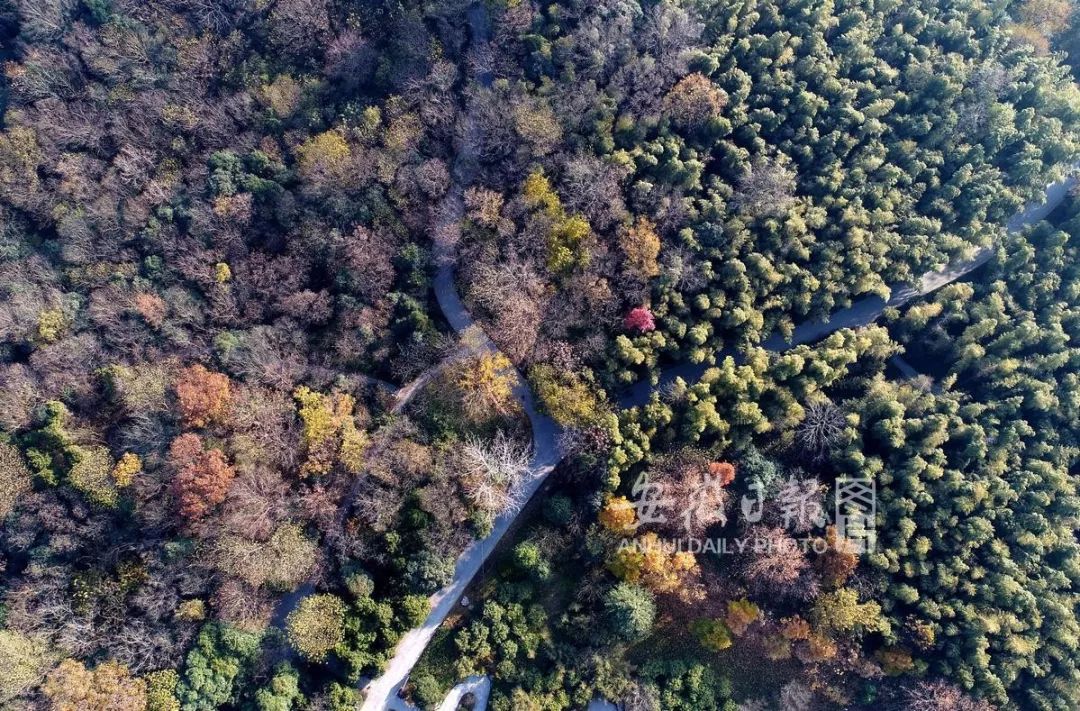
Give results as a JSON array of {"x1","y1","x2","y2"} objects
[{"x1": 460, "y1": 430, "x2": 532, "y2": 513}]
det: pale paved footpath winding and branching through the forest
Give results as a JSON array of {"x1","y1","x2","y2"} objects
[{"x1": 361, "y1": 8, "x2": 1078, "y2": 711}]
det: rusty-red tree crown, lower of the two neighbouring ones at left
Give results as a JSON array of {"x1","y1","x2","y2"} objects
[{"x1": 168, "y1": 432, "x2": 237, "y2": 521}]
